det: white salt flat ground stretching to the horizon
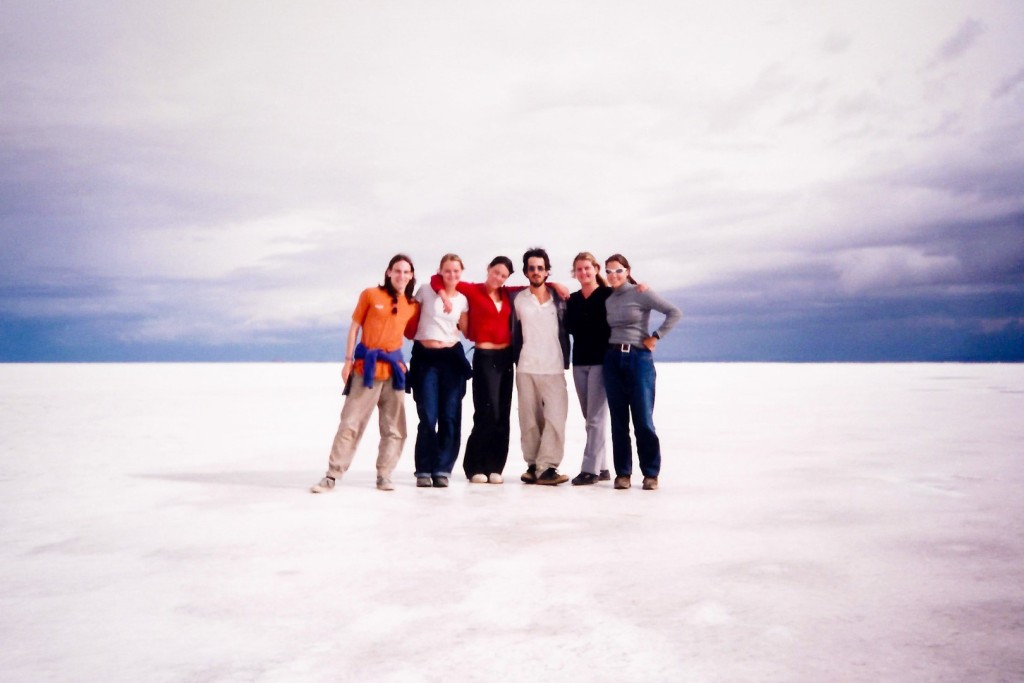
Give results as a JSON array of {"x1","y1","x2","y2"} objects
[{"x1": 0, "y1": 364, "x2": 1024, "y2": 683}]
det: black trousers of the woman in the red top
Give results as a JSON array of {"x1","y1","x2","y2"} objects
[{"x1": 462, "y1": 348, "x2": 512, "y2": 477}]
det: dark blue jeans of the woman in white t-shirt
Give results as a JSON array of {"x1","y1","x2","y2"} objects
[{"x1": 413, "y1": 348, "x2": 466, "y2": 477}]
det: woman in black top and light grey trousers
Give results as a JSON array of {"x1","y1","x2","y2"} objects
[{"x1": 565, "y1": 252, "x2": 611, "y2": 486}]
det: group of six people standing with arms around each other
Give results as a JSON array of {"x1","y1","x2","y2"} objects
[{"x1": 311, "y1": 248, "x2": 682, "y2": 494}]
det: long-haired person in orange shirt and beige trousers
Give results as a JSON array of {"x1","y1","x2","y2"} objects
[{"x1": 310, "y1": 254, "x2": 419, "y2": 494}]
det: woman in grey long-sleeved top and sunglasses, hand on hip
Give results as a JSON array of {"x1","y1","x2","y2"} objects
[{"x1": 604, "y1": 254, "x2": 683, "y2": 490}]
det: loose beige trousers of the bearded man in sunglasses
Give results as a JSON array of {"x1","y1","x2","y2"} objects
[{"x1": 515, "y1": 373, "x2": 569, "y2": 474}]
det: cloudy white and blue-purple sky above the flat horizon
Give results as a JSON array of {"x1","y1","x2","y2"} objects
[{"x1": 0, "y1": 0, "x2": 1024, "y2": 361}]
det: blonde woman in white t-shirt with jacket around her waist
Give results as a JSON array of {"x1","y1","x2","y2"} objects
[{"x1": 406, "y1": 254, "x2": 472, "y2": 488}]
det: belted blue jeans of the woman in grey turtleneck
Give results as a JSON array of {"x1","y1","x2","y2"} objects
[{"x1": 604, "y1": 346, "x2": 662, "y2": 477}]
